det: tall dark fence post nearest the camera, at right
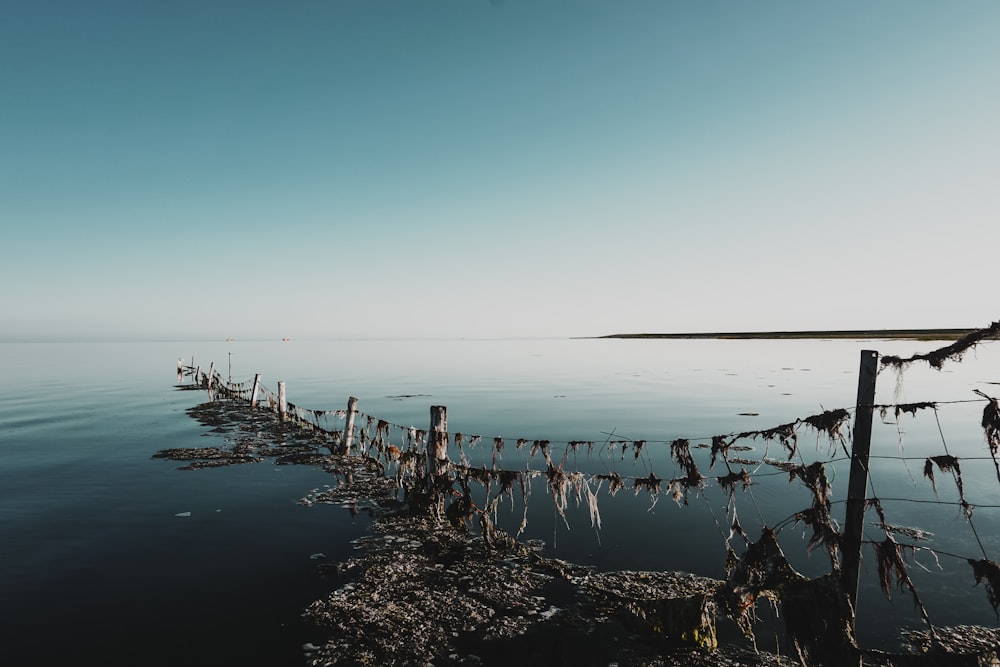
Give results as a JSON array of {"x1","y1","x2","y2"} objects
[{"x1": 841, "y1": 350, "x2": 878, "y2": 629}]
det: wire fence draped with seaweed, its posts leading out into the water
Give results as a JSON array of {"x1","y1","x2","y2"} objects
[{"x1": 178, "y1": 323, "x2": 1000, "y2": 664}]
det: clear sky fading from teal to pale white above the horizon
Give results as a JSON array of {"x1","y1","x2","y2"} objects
[{"x1": 0, "y1": 0, "x2": 1000, "y2": 340}]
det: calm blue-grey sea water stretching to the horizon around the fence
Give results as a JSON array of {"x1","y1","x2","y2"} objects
[{"x1": 0, "y1": 340, "x2": 1000, "y2": 665}]
